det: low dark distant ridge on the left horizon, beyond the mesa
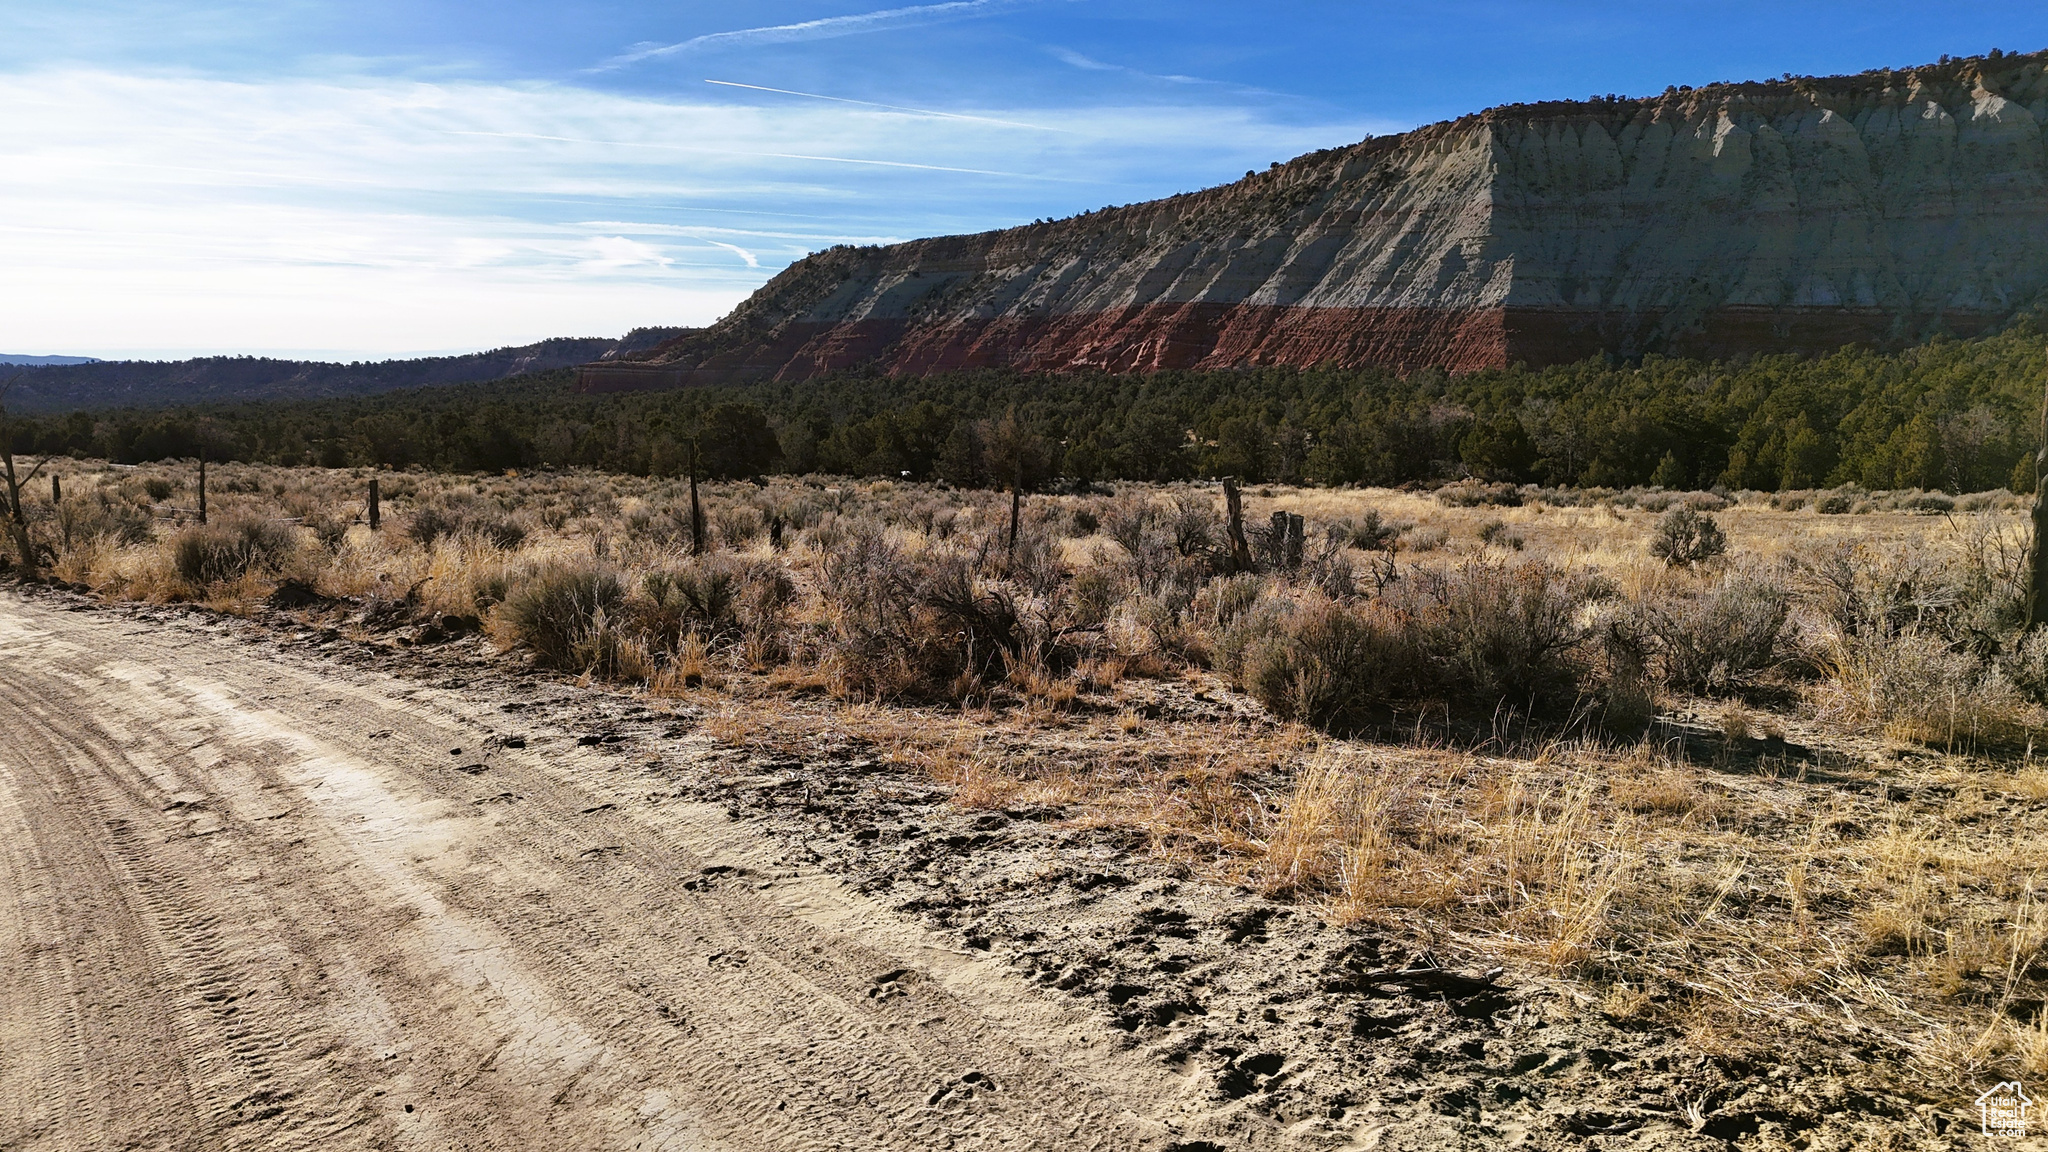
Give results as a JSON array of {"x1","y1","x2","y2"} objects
[{"x1": 6, "y1": 328, "x2": 690, "y2": 412}]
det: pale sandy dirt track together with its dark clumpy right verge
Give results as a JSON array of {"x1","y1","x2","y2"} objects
[{"x1": 0, "y1": 590, "x2": 1990, "y2": 1152}]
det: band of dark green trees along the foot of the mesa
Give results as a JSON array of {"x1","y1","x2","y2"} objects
[{"x1": 12, "y1": 320, "x2": 2048, "y2": 492}]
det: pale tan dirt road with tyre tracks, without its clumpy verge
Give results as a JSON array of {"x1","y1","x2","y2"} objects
[{"x1": 0, "y1": 592, "x2": 1200, "y2": 1150}]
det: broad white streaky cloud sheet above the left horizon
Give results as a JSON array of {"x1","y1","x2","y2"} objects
[{"x1": 0, "y1": 72, "x2": 1386, "y2": 357}]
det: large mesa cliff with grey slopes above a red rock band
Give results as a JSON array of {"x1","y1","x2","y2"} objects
[{"x1": 584, "y1": 53, "x2": 2048, "y2": 389}]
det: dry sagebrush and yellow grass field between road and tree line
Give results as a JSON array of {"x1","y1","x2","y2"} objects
[{"x1": 8, "y1": 461, "x2": 2048, "y2": 1146}]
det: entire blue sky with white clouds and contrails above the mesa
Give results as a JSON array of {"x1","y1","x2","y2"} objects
[{"x1": 0, "y1": 0, "x2": 2048, "y2": 359}]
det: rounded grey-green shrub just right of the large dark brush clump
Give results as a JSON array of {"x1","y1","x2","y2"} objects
[{"x1": 1642, "y1": 574, "x2": 1792, "y2": 693}]
